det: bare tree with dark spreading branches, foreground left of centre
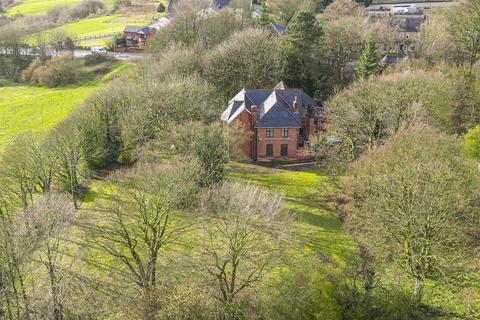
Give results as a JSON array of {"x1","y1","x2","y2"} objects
[{"x1": 85, "y1": 165, "x2": 195, "y2": 319}]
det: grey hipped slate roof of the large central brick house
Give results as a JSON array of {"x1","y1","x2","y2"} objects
[{"x1": 221, "y1": 84, "x2": 318, "y2": 128}]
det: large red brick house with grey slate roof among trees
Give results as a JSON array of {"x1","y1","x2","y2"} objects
[{"x1": 221, "y1": 83, "x2": 322, "y2": 161}]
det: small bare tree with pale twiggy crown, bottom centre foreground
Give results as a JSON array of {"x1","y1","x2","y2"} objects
[{"x1": 199, "y1": 184, "x2": 289, "y2": 306}]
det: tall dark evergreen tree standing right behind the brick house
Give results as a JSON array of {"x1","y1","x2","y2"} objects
[{"x1": 282, "y1": 11, "x2": 322, "y2": 93}]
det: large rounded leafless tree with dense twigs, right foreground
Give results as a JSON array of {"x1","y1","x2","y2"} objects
[{"x1": 345, "y1": 124, "x2": 478, "y2": 301}]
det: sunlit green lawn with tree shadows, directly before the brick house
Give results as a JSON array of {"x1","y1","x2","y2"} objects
[{"x1": 228, "y1": 164, "x2": 356, "y2": 266}]
